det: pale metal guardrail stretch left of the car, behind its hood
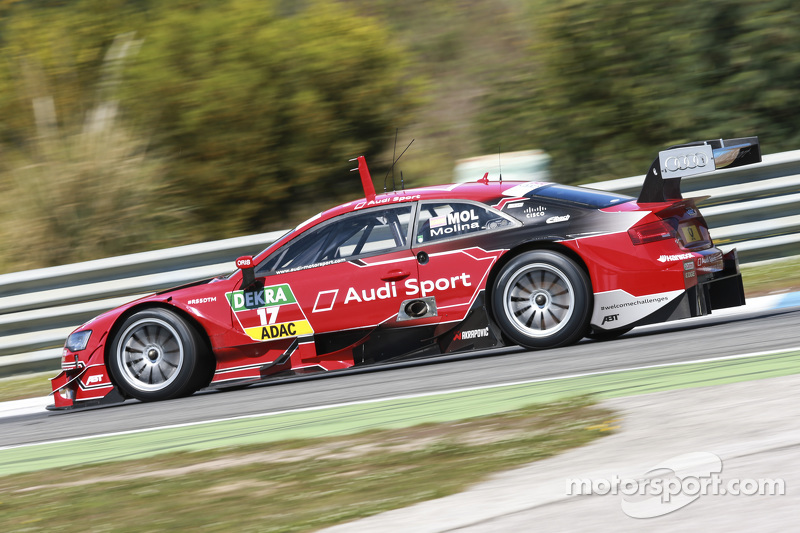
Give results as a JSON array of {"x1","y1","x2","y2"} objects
[{"x1": 0, "y1": 231, "x2": 285, "y2": 377}]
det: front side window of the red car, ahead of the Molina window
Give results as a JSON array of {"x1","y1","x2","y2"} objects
[{"x1": 256, "y1": 204, "x2": 413, "y2": 276}]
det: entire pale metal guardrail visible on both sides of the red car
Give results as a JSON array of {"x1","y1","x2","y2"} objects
[{"x1": 0, "y1": 150, "x2": 800, "y2": 376}]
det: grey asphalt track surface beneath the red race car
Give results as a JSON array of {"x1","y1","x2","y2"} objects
[{"x1": 0, "y1": 307, "x2": 800, "y2": 447}]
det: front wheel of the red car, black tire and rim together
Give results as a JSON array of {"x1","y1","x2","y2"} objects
[{"x1": 107, "y1": 308, "x2": 211, "y2": 402}]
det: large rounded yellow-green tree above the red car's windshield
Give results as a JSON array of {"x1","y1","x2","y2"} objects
[{"x1": 125, "y1": 0, "x2": 413, "y2": 238}]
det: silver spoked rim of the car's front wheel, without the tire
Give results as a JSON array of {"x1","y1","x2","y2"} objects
[{"x1": 117, "y1": 318, "x2": 185, "y2": 391}]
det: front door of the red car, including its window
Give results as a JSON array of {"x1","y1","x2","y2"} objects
[{"x1": 256, "y1": 203, "x2": 417, "y2": 342}]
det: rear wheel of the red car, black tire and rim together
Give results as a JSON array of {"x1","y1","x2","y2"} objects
[{"x1": 492, "y1": 250, "x2": 592, "y2": 350}]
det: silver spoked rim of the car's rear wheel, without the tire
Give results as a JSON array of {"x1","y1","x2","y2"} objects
[{"x1": 503, "y1": 263, "x2": 575, "y2": 337}]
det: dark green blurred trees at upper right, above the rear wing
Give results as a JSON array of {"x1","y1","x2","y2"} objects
[{"x1": 481, "y1": 0, "x2": 800, "y2": 182}]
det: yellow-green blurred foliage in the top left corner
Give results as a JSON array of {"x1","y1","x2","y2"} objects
[{"x1": 0, "y1": 0, "x2": 144, "y2": 148}]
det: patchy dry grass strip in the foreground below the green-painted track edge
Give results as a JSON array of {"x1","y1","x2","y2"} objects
[{"x1": 0, "y1": 398, "x2": 617, "y2": 532}]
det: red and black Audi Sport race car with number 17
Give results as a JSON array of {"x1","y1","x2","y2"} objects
[{"x1": 51, "y1": 137, "x2": 761, "y2": 409}]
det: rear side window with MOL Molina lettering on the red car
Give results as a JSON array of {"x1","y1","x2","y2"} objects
[{"x1": 416, "y1": 202, "x2": 514, "y2": 244}]
